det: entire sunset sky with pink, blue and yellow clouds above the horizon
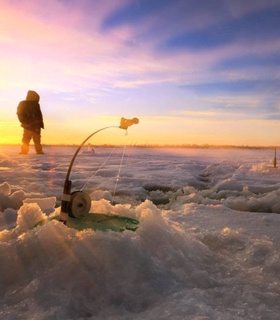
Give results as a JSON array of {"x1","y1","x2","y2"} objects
[{"x1": 0, "y1": 0, "x2": 280, "y2": 146}]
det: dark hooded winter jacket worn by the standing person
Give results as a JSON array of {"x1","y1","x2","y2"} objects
[{"x1": 17, "y1": 91, "x2": 44, "y2": 132}]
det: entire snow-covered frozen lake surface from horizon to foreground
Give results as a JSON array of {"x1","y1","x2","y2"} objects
[{"x1": 0, "y1": 147, "x2": 280, "y2": 320}]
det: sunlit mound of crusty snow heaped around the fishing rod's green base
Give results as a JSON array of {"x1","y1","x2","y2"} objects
[{"x1": 0, "y1": 201, "x2": 212, "y2": 319}]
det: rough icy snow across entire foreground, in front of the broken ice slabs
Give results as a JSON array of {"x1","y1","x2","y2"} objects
[{"x1": 0, "y1": 200, "x2": 280, "y2": 320}]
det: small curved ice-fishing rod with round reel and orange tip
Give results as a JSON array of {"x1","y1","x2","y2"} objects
[{"x1": 59, "y1": 118, "x2": 139, "y2": 224}]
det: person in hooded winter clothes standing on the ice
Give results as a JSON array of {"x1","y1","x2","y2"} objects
[{"x1": 17, "y1": 90, "x2": 44, "y2": 154}]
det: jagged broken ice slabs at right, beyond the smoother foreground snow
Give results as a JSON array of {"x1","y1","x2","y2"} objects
[{"x1": 166, "y1": 163, "x2": 280, "y2": 213}]
